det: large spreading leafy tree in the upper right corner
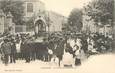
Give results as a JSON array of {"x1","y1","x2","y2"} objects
[{"x1": 85, "y1": 0, "x2": 114, "y2": 25}]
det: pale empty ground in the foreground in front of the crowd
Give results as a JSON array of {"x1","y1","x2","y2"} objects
[{"x1": 0, "y1": 54, "x2": 115, "y2": 73}]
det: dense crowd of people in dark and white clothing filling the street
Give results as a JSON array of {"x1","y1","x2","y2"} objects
[{"x1": 0, "y1": 33, "x2": 112, "y2": 67}]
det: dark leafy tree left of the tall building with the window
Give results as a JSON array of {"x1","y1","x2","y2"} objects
[{"x1": 0, "y1": 0, "x2": 24, "y2": 25}]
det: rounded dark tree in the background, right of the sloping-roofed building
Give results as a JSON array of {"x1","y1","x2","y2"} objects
[{"x1": 68, "y1": 9, "x2": 83, "y2": 32}]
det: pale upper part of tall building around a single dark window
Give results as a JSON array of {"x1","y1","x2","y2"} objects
[{"x1": 22, "y1": 0, "x2": 45, "y2": 20}]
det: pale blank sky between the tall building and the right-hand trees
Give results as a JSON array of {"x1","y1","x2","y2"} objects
[{"x1": 40, "y1": 0, "x2": 91, "y2": 16}]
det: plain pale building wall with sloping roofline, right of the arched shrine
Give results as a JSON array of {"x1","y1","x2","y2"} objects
[{"x1": 47, "y1": 11, "x2": 67, "y2": 32}]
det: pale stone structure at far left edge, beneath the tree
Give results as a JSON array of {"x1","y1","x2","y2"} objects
[{"x1": 0, "y1": 10, "x2": 15, "y2": 34}]
